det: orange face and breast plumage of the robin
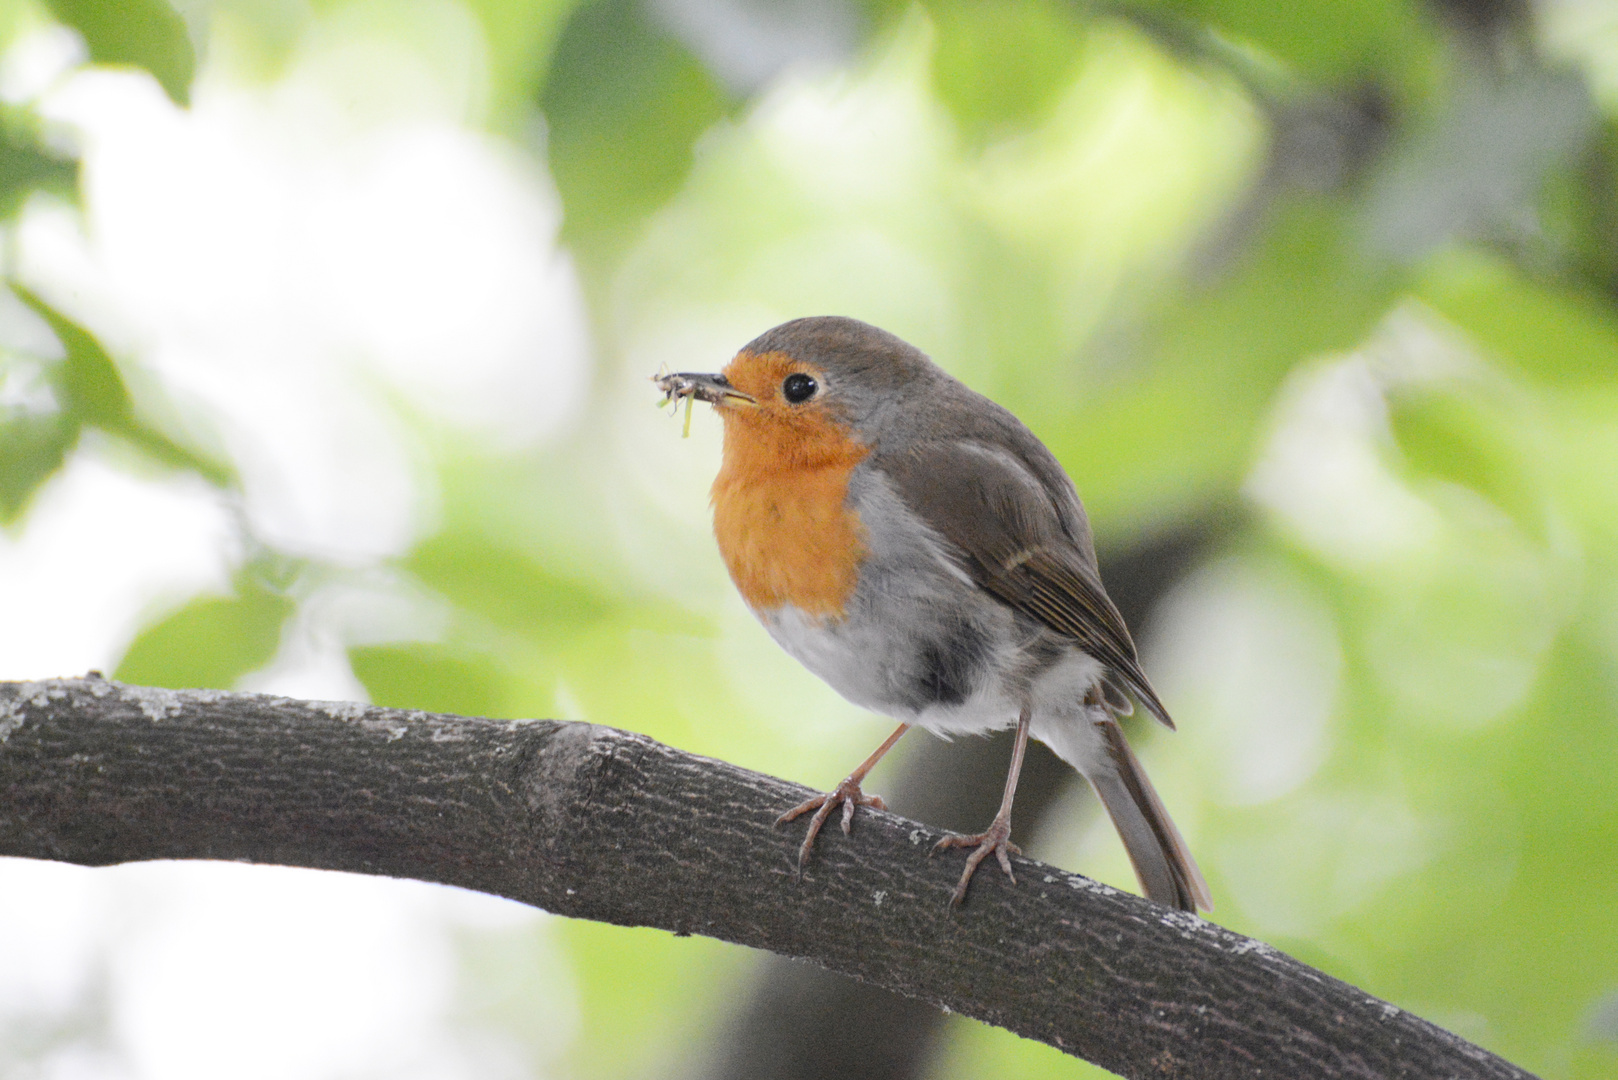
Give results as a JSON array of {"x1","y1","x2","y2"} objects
[{"x1": 714, "y1": 351, "x2": 870, "y2": 619}]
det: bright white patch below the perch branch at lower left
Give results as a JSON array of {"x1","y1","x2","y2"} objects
[{"x1": 0, "y1": 858, "x2": 563, "y2": 1080}]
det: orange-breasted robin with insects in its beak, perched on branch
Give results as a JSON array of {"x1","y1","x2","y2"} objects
[{"x1": 659, "y1": 317, "x2": 1212, "y2": 912}]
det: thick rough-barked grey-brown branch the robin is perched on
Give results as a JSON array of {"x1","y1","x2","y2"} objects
[{"x1": 0, "y1": 678, "x2": 1527, "y2": 1080}]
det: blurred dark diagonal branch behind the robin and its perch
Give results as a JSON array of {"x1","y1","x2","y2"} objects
[{"x1": 704, "y1": 513, "x2": 1225, "y2": 1080}]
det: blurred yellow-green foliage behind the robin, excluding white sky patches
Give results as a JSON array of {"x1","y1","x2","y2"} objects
[{"x1": 0, "y1": 0, "x2": 1618, "y2": 1080}]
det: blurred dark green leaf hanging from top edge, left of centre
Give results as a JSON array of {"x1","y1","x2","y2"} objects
[{"x1": 540, "y1": 0, "x2": 730, "y2": 268}]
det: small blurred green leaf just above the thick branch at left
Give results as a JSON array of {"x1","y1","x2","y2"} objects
[{"x1": 115, "y1": 580, "x2": 293, "y2": 690}]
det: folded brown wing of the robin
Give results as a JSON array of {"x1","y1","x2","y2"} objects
[{"x1": 874, "y1": 436, "x2": 1175, "y2": 727}]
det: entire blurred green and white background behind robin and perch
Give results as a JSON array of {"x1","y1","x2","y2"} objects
[{"x1": 0, "y1": 0, "x2": 1618, "y2": 1080}]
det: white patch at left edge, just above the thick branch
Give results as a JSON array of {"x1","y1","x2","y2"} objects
[{"x1": 0, "y1": 453, "x2": 235, "y2": 678}]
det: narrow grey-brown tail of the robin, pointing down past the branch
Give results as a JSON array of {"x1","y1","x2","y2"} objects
[{"x1": 1052, "y1": 712, "x2": 1214, "y2": 912}]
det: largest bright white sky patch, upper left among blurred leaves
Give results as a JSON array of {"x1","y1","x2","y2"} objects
[{"x1": 21, "y1": 23, "x2": 587, "y2": 563}]
